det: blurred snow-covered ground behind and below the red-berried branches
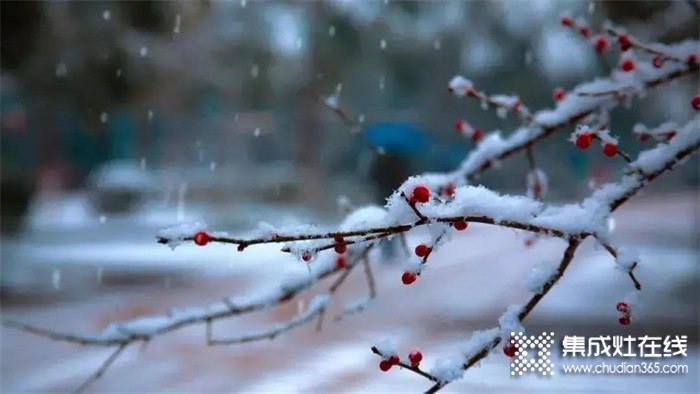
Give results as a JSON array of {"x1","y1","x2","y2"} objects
[{"x1": 0, "y1": 195, "x2": 700, "y2": 392}]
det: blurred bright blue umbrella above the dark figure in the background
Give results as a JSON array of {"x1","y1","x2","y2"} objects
[{"x1": 365, "y1": 122, "x2": 433, "y2": 155}]
